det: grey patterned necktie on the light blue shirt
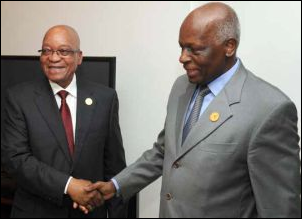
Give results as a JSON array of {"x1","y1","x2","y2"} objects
[{"x1": 182, "y1": 86, "x2": 210, "y2": 144}]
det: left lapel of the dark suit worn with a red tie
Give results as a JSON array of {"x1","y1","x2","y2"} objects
[{"x1": 35, "y1": 79, "x2": 72, "y2": 163}]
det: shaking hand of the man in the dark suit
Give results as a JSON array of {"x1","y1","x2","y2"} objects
[{"x1": 67, "y1": 178, "x2": 104, "y2": 207}]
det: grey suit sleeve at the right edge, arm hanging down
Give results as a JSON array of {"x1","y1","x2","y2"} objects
[{"x1": 248, "y1": 101, "x2": 301, "y2": 218}]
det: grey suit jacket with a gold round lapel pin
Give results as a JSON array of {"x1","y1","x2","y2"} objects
[{"x1": 115, "y1": 62, "x2": 301, "y2": 218}]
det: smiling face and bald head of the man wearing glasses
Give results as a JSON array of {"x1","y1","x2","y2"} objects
[{"x1": 40, "y1": 26, "x2": 82, "y2": 88}]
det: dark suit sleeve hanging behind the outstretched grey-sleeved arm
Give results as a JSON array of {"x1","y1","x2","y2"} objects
[{"x1": 104, "y1": 90, "x2": 128, "y2": 218}]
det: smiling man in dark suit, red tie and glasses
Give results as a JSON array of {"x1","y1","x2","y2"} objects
[{"x1": 1, "y1": 25, "x2": 127, "y2": 218}]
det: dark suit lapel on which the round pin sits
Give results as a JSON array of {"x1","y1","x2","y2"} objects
[{"x1": 73, "y1": 80, "x2": 97, "y2": 169}]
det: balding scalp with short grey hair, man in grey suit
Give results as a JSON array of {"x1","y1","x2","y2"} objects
[{"x1": 182, "y1": 2, "x2": 240, "y2": 46}]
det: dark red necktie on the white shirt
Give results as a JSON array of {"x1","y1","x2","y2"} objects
[{"x1": 58, "y1": 90, "x2": 74, "y2": 156}]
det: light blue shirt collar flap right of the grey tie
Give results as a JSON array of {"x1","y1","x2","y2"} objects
[{"x1": 208, "y1": 58, "x2": 240, "y2": 96}]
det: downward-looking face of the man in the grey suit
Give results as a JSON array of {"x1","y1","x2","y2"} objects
[{"x1": 179, "y1": 22, "x2": 225, "y2": 84}]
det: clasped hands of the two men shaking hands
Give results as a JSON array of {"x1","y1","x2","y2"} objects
[{"x1": 67, "y1": 178, "x2": 116, "y2": 214}]
